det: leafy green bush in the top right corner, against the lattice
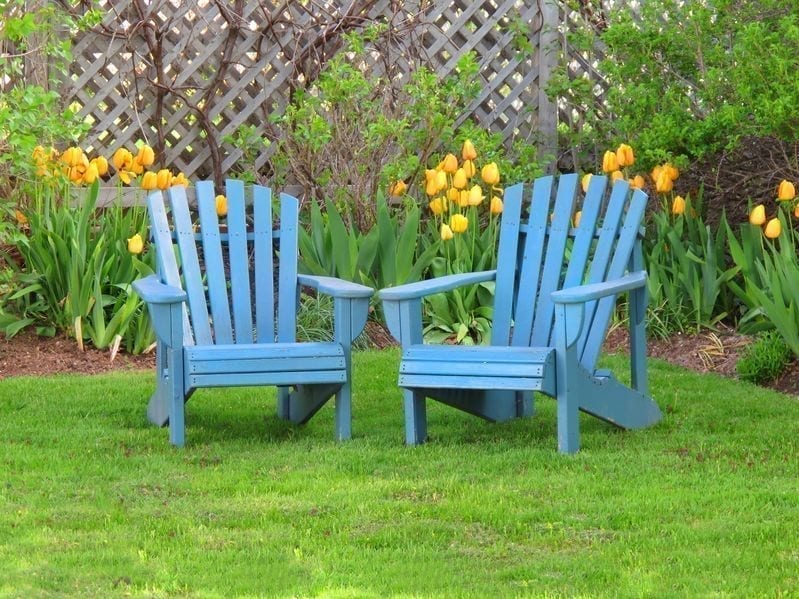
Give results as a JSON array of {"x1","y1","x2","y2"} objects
[{"x1": 549, "y1": 0, "x2": 799, "y2": 169}]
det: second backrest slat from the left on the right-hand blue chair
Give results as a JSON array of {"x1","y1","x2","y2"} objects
[{"x1": 510, "y1": 177, "x2": 555, "y2": 346}]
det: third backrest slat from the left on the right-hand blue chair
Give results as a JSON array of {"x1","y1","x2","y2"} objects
[{"x1": 530, "y1": 173, "x2": 579, "y2": 346}]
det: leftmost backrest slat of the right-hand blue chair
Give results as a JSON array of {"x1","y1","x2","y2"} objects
[{"x1": 491, "y1": 183, "x2": 524, "y2": 345}]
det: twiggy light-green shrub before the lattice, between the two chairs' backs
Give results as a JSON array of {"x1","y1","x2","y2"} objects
[{"x1": 272, "y1": 29, "x2": 479, "y2": 233}]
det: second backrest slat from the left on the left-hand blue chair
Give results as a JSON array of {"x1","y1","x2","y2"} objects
[{"x1": 167, "y1": 186, "x2": 213, "y2": 345}]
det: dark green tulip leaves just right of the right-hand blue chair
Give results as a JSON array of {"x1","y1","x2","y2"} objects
[{"x1": 644, "y1": 198, "x2": 740, "y2": 333}]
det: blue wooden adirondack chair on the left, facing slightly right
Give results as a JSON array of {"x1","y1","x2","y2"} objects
[{"x1": 134, "y1": 180, "x2": 372, "y2": 446}]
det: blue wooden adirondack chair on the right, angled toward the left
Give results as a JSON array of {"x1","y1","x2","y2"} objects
[{"x1": 379, "y1": 174, "x2": 661, "y2": 453}]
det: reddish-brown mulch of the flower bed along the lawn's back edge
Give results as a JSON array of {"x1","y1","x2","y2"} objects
[{"x1": 0, "y1": 321, "x2": 799, "y2": 395}]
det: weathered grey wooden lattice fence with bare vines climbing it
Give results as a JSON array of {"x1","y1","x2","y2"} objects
[{"x1": 65, "y1": 0, "x2": 558, "y2": 183}]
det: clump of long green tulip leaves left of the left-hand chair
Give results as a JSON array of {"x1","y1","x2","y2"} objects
[{"x1": 5, "y1": 183, "x2": 153, "y2": 353}]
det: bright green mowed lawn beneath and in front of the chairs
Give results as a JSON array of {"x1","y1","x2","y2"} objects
[{"x1": 0, "y1": 350, "x2": 799, "y2": 597}]
